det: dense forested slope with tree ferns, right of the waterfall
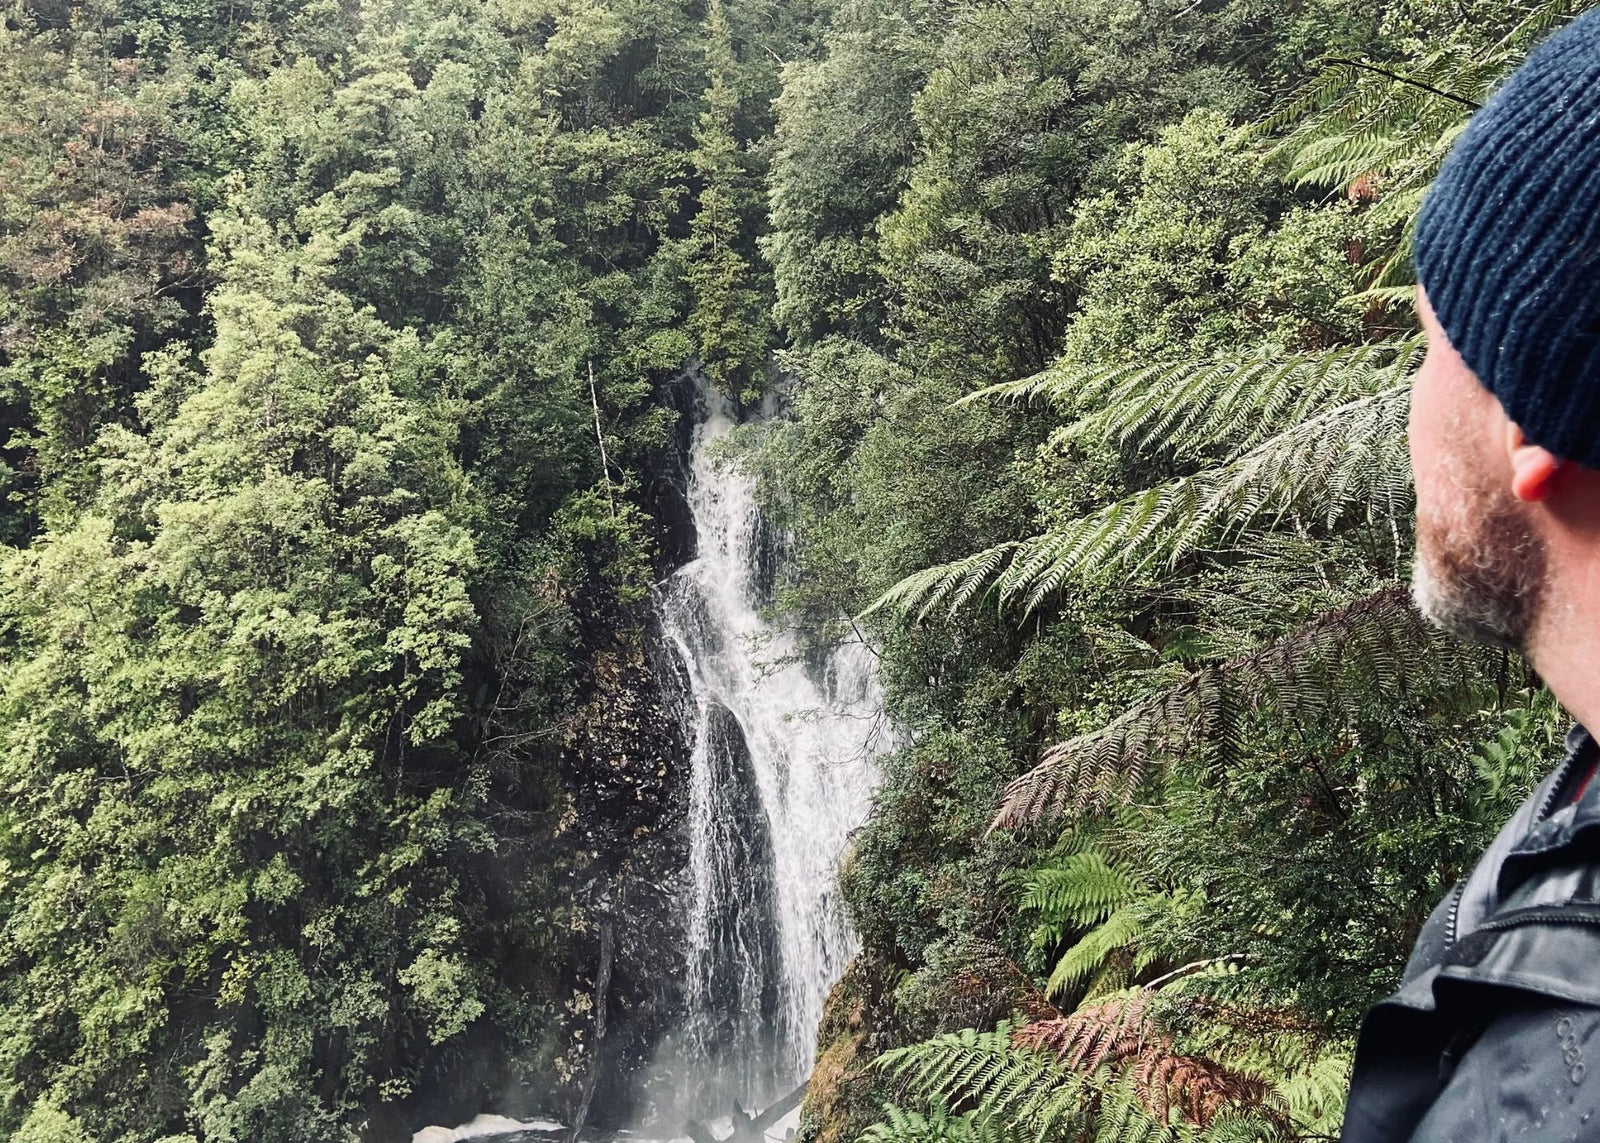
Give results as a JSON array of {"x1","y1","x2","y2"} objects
[{"x1": 757, "y1": 0, "x2": 1600, "y2": 1140}]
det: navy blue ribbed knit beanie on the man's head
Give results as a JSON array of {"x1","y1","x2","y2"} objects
[{"x1": 1416, "y1": 10, "x2": 1600, "y2": 469}]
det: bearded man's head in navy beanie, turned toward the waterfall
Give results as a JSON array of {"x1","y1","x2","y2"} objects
[{"x1": 1411, "y1": 13, "x2": 1600, "y2": 663}]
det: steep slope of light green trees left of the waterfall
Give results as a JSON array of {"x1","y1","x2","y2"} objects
[{"x1": 0, "y1": 0, "x2": 813, "y2": 1141}]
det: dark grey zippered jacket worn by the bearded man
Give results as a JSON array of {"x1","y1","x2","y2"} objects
[{"x1": 1344, "y1": 728, "x2": 1600, "y2": 1143}]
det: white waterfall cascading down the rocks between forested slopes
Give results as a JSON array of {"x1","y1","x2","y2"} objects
[{"x1": 659, "y1": 382, "x2": 891, "y2": 1114}]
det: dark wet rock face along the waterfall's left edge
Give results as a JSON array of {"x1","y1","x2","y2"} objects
[{"x1": 555, "y1": 378, "x2": 694, "y2": 1129}]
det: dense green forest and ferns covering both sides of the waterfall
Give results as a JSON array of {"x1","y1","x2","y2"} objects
[{"x1": 0, "y1": 0, "x2": 1584, "y2": 1143}]
